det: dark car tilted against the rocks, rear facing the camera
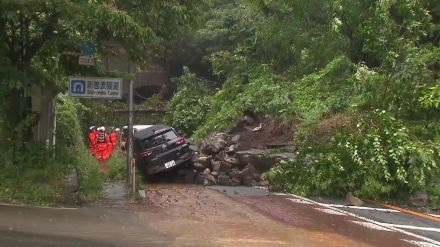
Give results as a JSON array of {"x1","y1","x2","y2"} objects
[{"x1": 133, "y1": 124, "x2": 192, "y2": 175}]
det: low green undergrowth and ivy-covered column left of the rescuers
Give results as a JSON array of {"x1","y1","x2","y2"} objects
[{"x1": 0, "y1": 95, "x2": 102, "y2": 205}]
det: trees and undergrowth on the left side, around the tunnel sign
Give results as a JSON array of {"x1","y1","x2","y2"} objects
[{"x1": 0, "y1": 0, "x2": 204, "y2": 204}]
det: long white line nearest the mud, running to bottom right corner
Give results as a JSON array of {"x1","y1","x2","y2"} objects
[{"x1": 277, "y1": 193, "x2": 440, "y2": 247}]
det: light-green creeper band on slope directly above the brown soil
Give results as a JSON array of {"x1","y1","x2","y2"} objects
[{"x1": 193, "y1": 57, "x2": 353, "y2": 139}]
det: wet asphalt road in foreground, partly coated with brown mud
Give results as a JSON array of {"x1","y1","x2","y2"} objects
[{"x1": 0, "y1": 184, "x2": 440, "y2": 247}]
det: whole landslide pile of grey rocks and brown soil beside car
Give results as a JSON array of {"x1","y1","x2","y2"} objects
[{"x1": 182, "y1": 116, "x2": 295, "y2": 186}]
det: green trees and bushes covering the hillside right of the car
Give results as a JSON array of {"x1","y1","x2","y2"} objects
[{"x1": 166, "y1": 0, "x2": 440, "y2": 203}]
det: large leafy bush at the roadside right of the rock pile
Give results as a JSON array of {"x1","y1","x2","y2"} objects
[{"x1": 269, "y1": 110, "x2": 440, "y2": 203}]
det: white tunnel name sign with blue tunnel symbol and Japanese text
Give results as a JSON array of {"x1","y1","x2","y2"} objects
[{"x1": 69, "y1": 76, "x2": 122, "y2": 99}]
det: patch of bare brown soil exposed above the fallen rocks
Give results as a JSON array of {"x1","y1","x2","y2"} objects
[{"x1": 230, "y1": 117, "x2": 296, "y2": 151}]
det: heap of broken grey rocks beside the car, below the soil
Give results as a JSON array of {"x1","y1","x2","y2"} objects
[{"x1": 188, "y1": 133, "x2": 293, "y2": 186}]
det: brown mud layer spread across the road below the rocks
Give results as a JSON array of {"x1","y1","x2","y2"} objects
[{"x1": 141, "y1": 184, "x2": 422, "y2": 246}]
